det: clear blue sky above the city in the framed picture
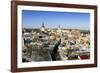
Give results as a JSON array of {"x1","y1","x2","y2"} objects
[{"x1": 22, "y1": 10, "x2": 90, "y2": 30}]
